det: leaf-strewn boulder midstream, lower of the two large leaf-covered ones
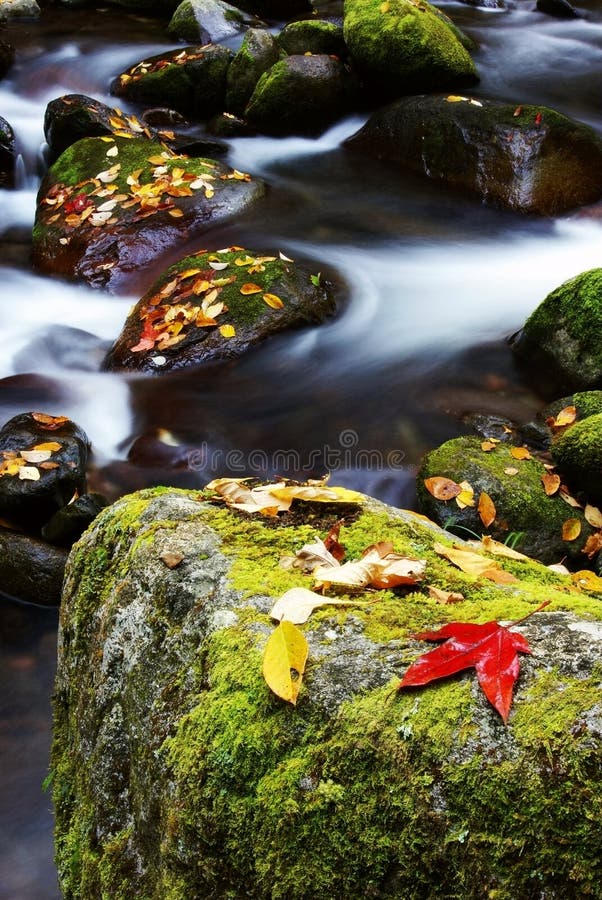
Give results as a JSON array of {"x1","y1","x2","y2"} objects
[{"x1": 105, "y1": 247, "x2": 337, "y2": 372}]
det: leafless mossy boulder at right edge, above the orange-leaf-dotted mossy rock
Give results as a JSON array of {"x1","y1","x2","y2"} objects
[{"x1": 551, "y1": 412, "x2": 602, "y2": 504}]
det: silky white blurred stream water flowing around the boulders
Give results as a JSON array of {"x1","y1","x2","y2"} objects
[{"x1": 0, "y1": 0, "x2": 602, "y2": 900}]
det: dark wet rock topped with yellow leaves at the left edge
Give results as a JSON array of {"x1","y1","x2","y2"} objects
[{"x1": 0, "y1": 413, "x2": 90, "y2": 532}]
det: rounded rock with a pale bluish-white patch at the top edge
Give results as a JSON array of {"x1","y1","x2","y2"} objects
[{"x1": 167, "y1": 0, "x2": 261, "y2": 44}]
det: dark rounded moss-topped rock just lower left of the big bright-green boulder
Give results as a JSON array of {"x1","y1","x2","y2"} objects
[{"x1": 245, "y1": 55, "x2": 357, "y2": 135}]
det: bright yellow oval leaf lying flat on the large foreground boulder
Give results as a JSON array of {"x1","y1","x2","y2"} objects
[{"x1": 262, "y1": 619, "x2": 309, "y2": 706}]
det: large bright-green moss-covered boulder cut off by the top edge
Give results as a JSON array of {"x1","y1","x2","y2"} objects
[{"x1": 344, "y1": 0, "x2": 478, "y2": 97}]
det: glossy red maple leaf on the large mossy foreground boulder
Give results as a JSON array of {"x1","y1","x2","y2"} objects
[{"x1": 398, "y1": 601, "x2": 549, "y2": 722}]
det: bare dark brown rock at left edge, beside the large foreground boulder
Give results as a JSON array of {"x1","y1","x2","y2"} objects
[{"x1": 0, "y1": 526, "x2": 67, "y2": 606}]
